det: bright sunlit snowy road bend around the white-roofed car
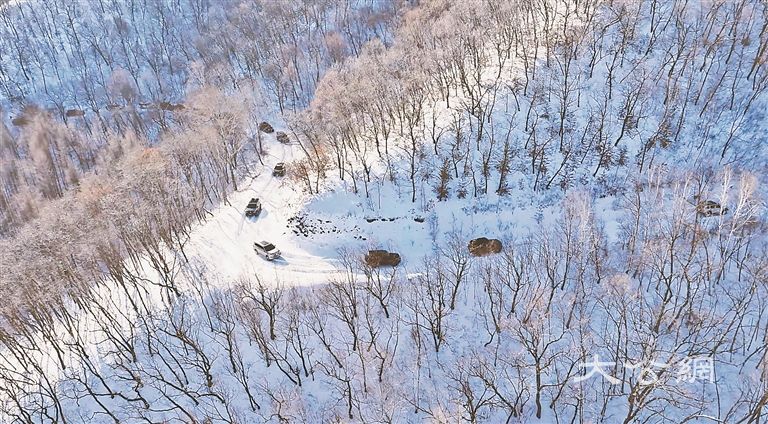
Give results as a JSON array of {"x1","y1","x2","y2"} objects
[{"x1": 187, "y1": 135, "x2": 344, "y2": 285}]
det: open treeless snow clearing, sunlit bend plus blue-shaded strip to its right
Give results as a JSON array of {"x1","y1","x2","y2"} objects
[{"x1": 185, "y1": 136, "x2": 615, "y2": 286}]
